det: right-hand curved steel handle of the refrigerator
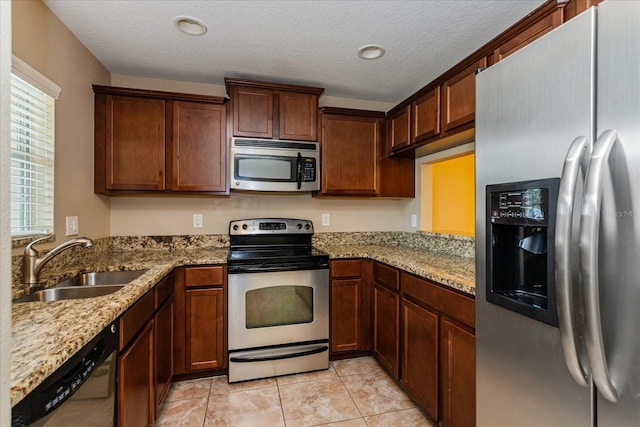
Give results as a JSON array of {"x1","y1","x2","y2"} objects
[{"x1": 580, "y1": 130, "x2": 618, "y2": 402}]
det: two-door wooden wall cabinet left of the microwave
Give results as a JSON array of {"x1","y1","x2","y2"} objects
[{"x1": 93, "y1": 85, "x2": 229, "y2": 194}]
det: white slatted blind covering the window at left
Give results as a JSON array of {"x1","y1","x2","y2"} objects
[{"x1": 11, "y1": 74, "x2": 55, "y2": 237}]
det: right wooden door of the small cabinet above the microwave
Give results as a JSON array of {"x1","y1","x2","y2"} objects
[{"x1": 278, "y1": 92, "x2": 318, "y2": 141}]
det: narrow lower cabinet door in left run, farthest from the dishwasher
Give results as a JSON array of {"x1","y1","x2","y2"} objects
[{"x1": 153, "y1": 297, "x2": 175, "y2": 414}]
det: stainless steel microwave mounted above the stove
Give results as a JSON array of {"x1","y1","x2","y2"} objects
[{"x1": 229, "y1": 138, "x2": 320, "y2": 192}]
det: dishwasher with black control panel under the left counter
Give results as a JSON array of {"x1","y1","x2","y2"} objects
[{"x1": 11, "y1": 323, "x2": 118, "y2": 427}]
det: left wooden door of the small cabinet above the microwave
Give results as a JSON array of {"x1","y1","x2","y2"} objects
[{"x1": 231, "y1": 86, "x2": 273, "y2": 138}]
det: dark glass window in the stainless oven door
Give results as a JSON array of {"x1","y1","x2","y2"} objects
[{"x1": 245, "y1": 285, "x2": 313, "y2": 329}]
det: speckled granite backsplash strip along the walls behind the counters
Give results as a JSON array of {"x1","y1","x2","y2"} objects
[{"x1": 12, "y1": 231, "x2": 475, "y2": 294}]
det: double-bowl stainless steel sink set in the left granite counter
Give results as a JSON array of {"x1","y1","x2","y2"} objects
[{"x1": 13, "y1": 270, "x2": 148, "y2": 303}]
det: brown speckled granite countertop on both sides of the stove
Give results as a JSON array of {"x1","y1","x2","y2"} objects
[{"x1": 11, "y1": 244, "x2": 475, "y2": 406}]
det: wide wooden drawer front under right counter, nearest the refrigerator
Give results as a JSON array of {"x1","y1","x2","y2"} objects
[{"x1": 401, "y1": 273, "x2": 476, "y2": 328}]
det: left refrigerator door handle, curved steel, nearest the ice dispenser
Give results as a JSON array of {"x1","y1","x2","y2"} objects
[{"x1": 555, "y1": 136, "x2": 591, "y2": 387}]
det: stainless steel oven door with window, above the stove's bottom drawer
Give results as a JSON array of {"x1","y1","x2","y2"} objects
[{"x1": 228, "y1": 268, "x2": 329, "y2": 351}]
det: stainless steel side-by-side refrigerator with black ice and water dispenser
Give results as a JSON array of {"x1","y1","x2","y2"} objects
[{"x1": 476, "y1": 0, "x2": 640, "y2": 427}]
